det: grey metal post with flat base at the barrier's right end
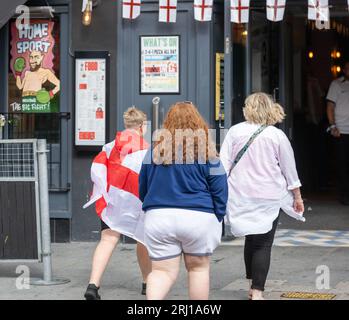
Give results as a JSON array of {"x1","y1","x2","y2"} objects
[{"x1": 30, "y1": 139, "x2": 70, "y2": 285}]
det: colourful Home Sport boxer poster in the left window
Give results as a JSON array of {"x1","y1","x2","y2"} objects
[{"x1": 9, "y1": 20, "x2": 60, "y2": 113}]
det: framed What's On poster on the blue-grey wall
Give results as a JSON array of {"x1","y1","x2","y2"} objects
[{"x1": 140, "y1": 36, "x2": 180, "y2": 94}]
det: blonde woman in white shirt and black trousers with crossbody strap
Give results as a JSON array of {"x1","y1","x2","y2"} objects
[{"x1": 220, "y1": 93, "x2": 304, "y2": 300}]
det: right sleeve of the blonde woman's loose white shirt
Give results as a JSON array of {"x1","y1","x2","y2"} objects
[{"x1": 278, "y1": 133, "x2": 302, "y2": 190}]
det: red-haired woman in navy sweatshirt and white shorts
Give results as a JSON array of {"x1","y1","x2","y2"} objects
[{"x1": 139, "y1": 102, "x2": 228, "y2": 300}]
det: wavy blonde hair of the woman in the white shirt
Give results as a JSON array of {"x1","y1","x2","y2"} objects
[{"x1": 243, "y1": 92, "x2": 286, "y2": 126}]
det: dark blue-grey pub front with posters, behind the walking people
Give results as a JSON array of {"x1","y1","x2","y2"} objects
[{"x1": 0, "y1": 0, "x2": 349, "y2": 242}]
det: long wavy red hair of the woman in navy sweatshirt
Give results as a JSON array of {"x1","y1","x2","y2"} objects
[{"x1": 153, "y1": 102, "x2": 217, "y2": 165}]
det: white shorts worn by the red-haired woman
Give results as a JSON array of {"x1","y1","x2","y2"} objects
[{"x1": 144, "y1": 208, "x2": 222, "y2": 261}]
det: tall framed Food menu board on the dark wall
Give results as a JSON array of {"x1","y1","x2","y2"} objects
[{"x1": 75, "y1": 52, "x2": 109, "y2": 147}]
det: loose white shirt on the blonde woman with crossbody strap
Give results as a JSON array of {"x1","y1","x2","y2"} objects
[{"x1": 220, "y1": 122, "x2": 305, "y2": 236}]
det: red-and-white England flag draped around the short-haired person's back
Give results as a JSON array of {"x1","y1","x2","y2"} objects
[{"x1": 84, "y1": 130, "x2": 149, "y2": 243}]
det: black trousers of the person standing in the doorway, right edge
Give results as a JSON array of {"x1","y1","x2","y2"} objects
[{"x1": 335, "y1": 134, "x2": 349, "y2": 201}]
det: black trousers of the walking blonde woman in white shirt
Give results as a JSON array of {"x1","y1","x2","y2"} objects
[{"x1": 244, "y1": 218, "x2": 279, "y2": 291}]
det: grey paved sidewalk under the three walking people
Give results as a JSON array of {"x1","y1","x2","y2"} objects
[{"x1": 0, "y1": 243, "x2": 349, "y2": 300}]
